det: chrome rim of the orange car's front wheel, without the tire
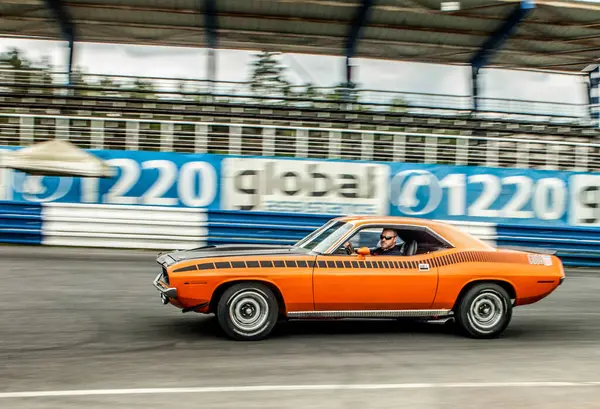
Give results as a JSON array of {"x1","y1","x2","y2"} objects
[{"x1": 229, "y1": 290, "x2": 269, "y2": 336}]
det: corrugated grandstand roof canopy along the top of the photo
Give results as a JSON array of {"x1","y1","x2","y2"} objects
[{"x1": 0, "y1": 0, "x2": 600, "y2": 72}]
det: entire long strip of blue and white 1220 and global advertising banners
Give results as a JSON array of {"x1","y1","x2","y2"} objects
[{"x1": 0, "y1": 148, "x2": 600, "y2": 227}]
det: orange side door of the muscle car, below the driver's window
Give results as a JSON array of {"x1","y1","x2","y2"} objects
[{"x1": 313, "y1": 228, "x2": 438, "y2": 311}]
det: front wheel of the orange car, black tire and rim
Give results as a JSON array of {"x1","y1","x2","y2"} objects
[{"x1": 216, "y1": 283, "x2": 279, "y2": 341}]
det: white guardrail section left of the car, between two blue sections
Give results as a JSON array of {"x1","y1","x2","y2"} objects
[{"x1": 42, "y1": 203, "x2": 208, "y2": 250}]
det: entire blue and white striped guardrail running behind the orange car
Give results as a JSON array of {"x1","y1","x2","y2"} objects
[{"x1": 8, "y1": 202, "x2": 600, "y2": 268}]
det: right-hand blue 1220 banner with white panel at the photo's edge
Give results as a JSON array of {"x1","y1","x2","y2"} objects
[{"x1": 389, "y1": 163, "x2": 600, "y2": 226}]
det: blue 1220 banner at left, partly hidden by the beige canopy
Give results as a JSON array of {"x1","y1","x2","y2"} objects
[{"x1": 2, "y1": 150, "x2": 221, "y2": 208}]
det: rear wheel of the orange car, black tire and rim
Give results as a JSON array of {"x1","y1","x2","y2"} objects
[{"x1": 454, "y1": 283, "x2": 512, "y2": 339}]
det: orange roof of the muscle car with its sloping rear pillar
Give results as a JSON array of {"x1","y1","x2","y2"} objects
[{"x1": 336, "y1": 216, "x2": 493, "y2": 250}]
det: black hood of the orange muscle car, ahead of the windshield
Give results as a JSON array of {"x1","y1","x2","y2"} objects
[{"x1": 156, "y1": 244, "x2": 310, "y2": 267}]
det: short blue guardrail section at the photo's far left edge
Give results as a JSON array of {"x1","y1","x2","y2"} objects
[{"x1": 0, "y1": 201, "x2": 43, "y2": 244}]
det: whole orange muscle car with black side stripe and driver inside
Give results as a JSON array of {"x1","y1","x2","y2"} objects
[{"x1": 154, "y1": 216, "x2": 565, "y2": 340}]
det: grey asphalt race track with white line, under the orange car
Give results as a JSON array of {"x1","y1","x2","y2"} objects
[{"x1": 0, "y1": 246, "x2": 600, "y2": 409}]
